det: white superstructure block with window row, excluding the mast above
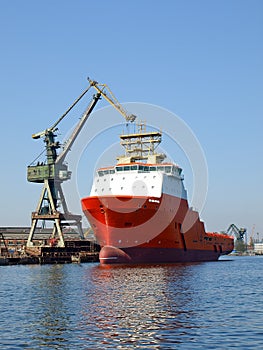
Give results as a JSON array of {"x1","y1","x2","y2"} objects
[{"x1": 90, "y1": 163, "x2": 187, "y2": 199}]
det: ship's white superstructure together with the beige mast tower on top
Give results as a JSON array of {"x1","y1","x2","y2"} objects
[{"x1": 90, "y1": 123, "x2": 187, "y2": 199}]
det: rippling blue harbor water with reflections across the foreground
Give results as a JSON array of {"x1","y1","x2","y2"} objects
[{"x1": 0, "y1": 256, "x2": 263, "y2": 350}]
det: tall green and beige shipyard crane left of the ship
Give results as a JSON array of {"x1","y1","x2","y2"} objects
[{"x1": 27, "y1": 78, "x2": 136, "y2": 247}]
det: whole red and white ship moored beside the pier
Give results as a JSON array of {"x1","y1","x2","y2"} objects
[{"x1": 81, "y1": 122, "x2": 234, "y2": 264}]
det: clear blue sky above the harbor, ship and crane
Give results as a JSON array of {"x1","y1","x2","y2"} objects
[{"x1": 0, "y1": 0, "x2": 263, "y2": 238}]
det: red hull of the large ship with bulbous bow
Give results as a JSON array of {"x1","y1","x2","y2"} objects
[{"x1": 81, "y1": 194, "x2": 234, "y2": 264}]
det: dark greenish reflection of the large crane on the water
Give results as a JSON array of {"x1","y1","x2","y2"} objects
[{"x1": 29, "y1": 265, "x2": 73, "y2": 349}]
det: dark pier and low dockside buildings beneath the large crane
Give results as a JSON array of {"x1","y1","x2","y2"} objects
[{"x1": 0, "y1": 227, "x2": 100, "y2": 265}]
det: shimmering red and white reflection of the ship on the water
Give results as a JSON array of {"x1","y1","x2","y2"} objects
[{"x1": 81, "y1": 264, "x2": 201, "y2": 349}]
